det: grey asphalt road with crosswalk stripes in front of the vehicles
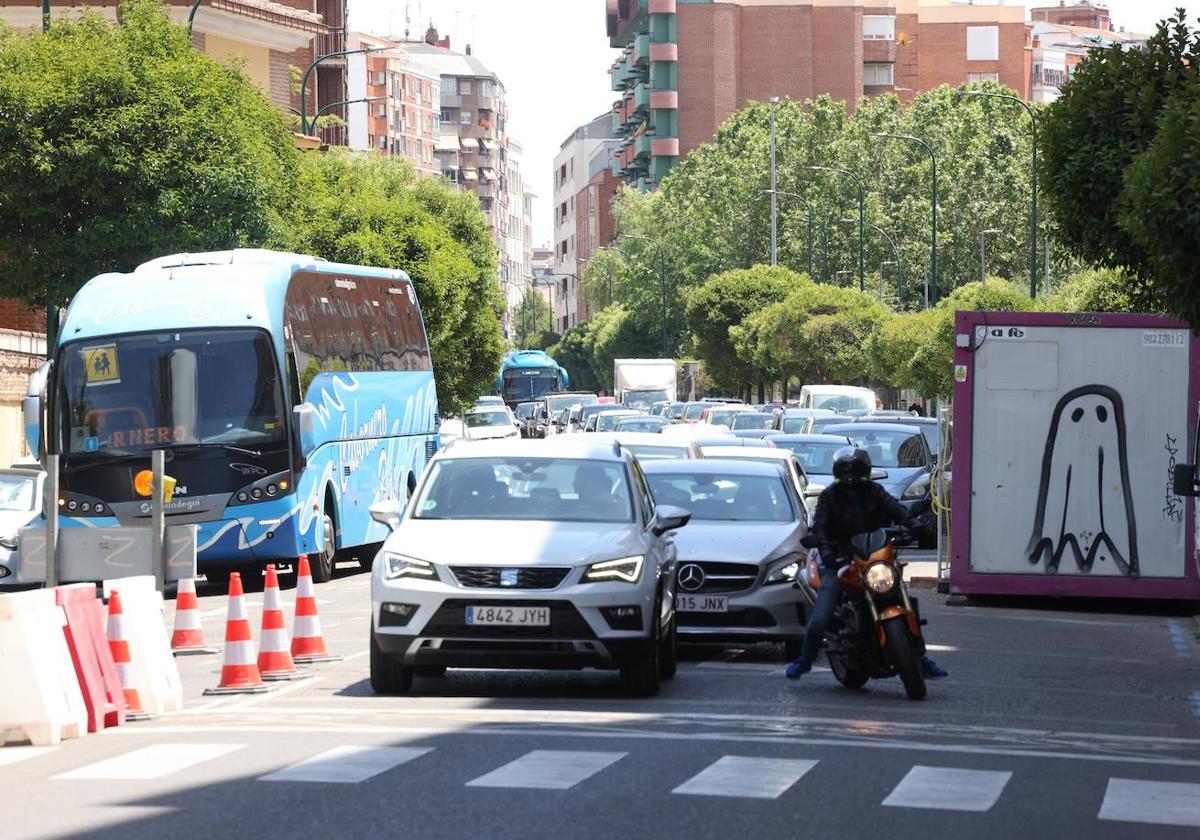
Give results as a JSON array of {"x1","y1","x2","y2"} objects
[{"x1": 0, "y1": 556, "x2": 1200, "y2": 840}]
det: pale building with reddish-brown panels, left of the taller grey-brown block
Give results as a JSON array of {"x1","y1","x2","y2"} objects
[{"x1": 347, "y1": 32, "x2": 442, "y2": 176}]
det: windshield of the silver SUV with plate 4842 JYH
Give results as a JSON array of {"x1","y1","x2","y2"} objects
[{"x1": 413, "y1": 457, "x2": 634, "y2": 522}]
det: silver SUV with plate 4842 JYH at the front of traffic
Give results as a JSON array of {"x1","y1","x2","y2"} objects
[{"x1": 371, "y1": 438, "x2": 690, "y2": 696}]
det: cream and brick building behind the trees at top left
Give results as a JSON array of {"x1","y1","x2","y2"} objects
[{"x1": 0, "y1": 0, "x2": 347, "y2": 144}]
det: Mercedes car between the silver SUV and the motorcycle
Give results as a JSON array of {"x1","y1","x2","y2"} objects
[{"x1": 643, "y1": 458, "x2": 809, "y2": 658}]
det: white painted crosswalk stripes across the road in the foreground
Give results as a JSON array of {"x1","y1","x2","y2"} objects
[{"x1": 0, "y1": 742, "x2": 1200, "y2": 828}]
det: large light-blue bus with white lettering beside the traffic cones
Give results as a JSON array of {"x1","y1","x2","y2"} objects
[{"x1": 26, "y1": 250, "x2": 439, "y2": 581}]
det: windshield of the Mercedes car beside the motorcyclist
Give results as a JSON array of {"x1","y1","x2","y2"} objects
[{"x1": 646, "y1": 473, "x2": 796, "y2": 522}]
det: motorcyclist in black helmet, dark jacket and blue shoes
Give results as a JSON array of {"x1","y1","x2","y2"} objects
[{"x1": 786, "y1": 446, "x2": 947, "y2": 679}]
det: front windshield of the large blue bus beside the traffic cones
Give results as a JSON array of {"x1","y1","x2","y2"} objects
[{"x1": 56, "y1": 329, "x2": 287, "y2": 454}]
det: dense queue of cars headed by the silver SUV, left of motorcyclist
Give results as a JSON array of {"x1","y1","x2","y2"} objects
[{"x1": 371, "y1": 381, "x2": 938, "y2": 696}]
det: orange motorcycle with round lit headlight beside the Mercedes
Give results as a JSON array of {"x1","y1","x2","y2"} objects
[{"x1": 797, "y1": 528, "x2": 925, "y2": 700}]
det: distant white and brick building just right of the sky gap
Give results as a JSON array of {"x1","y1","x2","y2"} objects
[{"x1": 553, "y1": 114, "x2": 619, "y2": 334}]
